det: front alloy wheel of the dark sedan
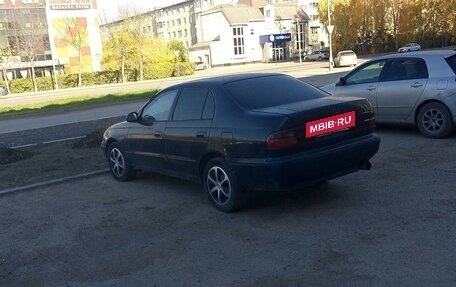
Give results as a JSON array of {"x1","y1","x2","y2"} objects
[{"x1": 107, "y1": 142, "x2": 136, "y2": 181}]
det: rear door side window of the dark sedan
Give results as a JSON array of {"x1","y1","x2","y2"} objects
[{"x1": 173, "y1": 88, "x2": 209, "y2": 121}]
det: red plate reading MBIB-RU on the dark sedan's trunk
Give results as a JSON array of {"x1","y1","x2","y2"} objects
[{"x1": 306, "y1": 111, "x2": 355, "y2": 138}]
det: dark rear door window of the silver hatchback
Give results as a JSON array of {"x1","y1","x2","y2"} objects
[{"x1": 384, "y1": 58, "x2": 428, "y2": 81}]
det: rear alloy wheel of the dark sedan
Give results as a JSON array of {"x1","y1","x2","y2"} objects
[{"x1": 203, "y1": 158, "x2": 248, "y2": 212}]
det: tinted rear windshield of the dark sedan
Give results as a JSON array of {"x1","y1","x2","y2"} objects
[{"x1": 224, "y1": 75, "x2": 328, "y2": 110}]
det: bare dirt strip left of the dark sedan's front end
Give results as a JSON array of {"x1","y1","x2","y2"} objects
[{"x1": 0, "y1": 134, "x2": 107, "y2": 191}]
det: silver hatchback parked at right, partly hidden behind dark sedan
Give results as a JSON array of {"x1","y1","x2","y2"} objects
[{"x1": 321, "y1": 50, "x2": 456, "y2": 138}]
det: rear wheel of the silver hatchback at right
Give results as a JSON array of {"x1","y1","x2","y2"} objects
[{"x1": 417, "y1": 102, "x2": 454, "y2": 138}]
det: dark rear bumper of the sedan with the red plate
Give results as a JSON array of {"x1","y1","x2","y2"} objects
[{"x1": 230, "y1": 134, "x2": 380, "y2": 190}]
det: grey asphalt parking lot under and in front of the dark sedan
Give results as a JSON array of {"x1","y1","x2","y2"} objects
[{"x1": 0, "y1": 126, "x2": 456, "y2": 287}]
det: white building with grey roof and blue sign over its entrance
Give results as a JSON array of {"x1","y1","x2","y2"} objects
[{"x1": 189, "y1": 4, "x2": 309, "y2": 66}]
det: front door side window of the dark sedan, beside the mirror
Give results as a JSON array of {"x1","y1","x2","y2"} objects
[{"x1": 141, "y1": 89, "x2": 178, "y2": 122}]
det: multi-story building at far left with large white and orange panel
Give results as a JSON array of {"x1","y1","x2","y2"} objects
[{"x1": 0, "y1": 0, "x2": 102, "y2": 79}]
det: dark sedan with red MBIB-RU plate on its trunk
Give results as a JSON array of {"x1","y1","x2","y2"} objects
[{"x1": 101, "y1": 73, "x2": 380, "y2": 212}]
